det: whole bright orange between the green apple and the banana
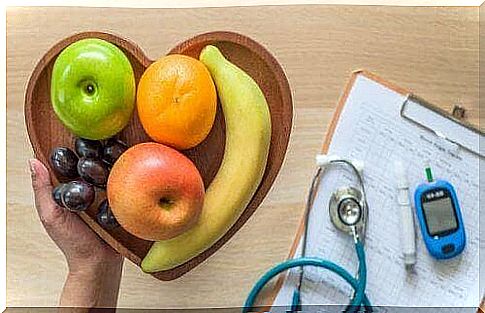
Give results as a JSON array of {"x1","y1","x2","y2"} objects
[{"x1": 136, "y1": 54, "x2": 217, "y2": 150}]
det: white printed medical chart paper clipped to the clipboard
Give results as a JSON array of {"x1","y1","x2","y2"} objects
[{"x1": 274, "y1": 75, "x2": 481, "y2": 312}]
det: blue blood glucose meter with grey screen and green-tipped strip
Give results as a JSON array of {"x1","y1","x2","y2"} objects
[{"x1": 414, "y1": 168, "x2": 466, "y2": 259}]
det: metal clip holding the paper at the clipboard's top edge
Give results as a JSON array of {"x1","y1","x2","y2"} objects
[{"x1": 400, "y1": 93, "x2": 485, "y2": 159}]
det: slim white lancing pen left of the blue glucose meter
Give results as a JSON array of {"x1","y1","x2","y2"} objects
[{"x1": 396, "y1": 162, "x2": 416, "y2": 270}]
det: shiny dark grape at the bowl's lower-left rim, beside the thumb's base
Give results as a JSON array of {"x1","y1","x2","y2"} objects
[{"x1": 61, "y1": 180, "x2": 95, "y2": 212}]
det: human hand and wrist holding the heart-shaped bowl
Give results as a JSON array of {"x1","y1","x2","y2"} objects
[{"x1": 29, "y1": 159, "x2": 123, "y2": 307}]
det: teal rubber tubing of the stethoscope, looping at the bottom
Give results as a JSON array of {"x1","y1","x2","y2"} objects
[{"x1": 242, "y1": 241, "x2": 372, "y2": 313}]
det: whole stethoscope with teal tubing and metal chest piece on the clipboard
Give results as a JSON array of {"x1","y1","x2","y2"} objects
[{"x1": 243, "y1": 155, "x2": 372, "y2": 313}]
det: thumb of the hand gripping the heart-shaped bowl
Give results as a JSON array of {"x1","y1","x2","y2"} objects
[{"x1": 29, "y1": 159, "x2": 65, "y2": 225}]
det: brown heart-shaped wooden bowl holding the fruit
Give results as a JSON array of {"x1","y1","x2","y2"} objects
[{"x1": 25, "y1": 32, "x2": 293, "y2": 280}]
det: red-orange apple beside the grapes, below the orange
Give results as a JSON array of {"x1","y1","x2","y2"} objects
[{"x1": 107, "y1": 142, "x2": 204, "y2": 240}]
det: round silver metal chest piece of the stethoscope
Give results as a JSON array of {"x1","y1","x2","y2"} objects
[{"x1": 329, "y1": 187, "x2": 368, "y2": 241}]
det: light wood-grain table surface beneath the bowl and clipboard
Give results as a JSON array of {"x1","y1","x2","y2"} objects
[{"x1": 7, "y1": 5, "x2": 479, "y2": 308}]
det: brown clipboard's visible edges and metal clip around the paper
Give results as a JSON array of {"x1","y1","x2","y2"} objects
[{"x1": 261, "y1": 70, "x2": 485, "y2": 312}]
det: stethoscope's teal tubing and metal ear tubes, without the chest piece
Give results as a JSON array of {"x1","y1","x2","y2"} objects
[{"x1": 242, "y1": 160, "x2": 372, "y2": 313}]
